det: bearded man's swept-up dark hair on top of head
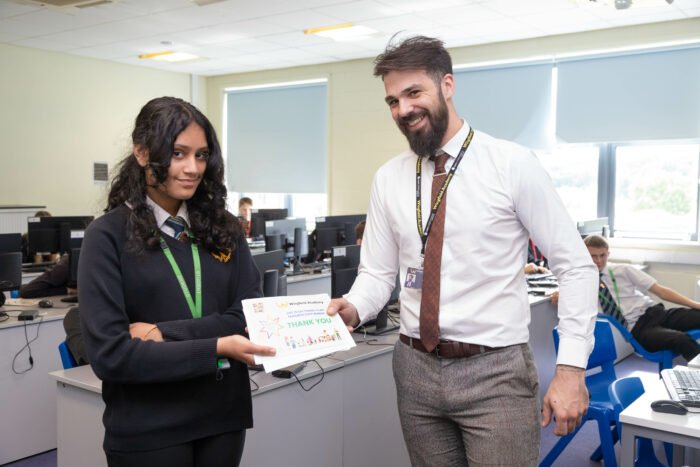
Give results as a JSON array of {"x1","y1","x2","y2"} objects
[{"x1": 374, "y1": 36, "x2": 452, "y2": 84}]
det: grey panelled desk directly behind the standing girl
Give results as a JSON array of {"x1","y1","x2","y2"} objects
[{"x1": 51, "y1": 334, "x2": 410, "y2": 467}]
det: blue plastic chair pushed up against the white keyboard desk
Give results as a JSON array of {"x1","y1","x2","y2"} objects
[{"x1": 608, "y1": 376, "x2": 673, "y2": 467}]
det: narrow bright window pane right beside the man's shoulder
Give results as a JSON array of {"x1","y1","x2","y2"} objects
[{"x1": 537, "y1": 145, "x2": 600, "y2": 221}]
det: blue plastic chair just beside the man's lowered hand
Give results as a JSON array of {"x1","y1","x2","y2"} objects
[{"x1": 540, "y1": 320, "x2": 619, "y2": 467}]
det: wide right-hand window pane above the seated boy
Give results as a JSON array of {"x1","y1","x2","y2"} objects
[{"x1": 613, "y1": 144, "x2": 700, "y2": 240}]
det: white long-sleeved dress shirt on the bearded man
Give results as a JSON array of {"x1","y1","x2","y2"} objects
[{"x1": 345, "y1": 123, "x2": 598, "y2": 368}]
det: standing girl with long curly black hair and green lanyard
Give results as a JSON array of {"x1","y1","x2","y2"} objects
[{"x1": 78, "y1": 97, "x2": 274, "y2": 467}]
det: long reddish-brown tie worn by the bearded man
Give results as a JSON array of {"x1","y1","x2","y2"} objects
[{"x1": 420, "y1": 152, "x2": 450, "y2": 352}]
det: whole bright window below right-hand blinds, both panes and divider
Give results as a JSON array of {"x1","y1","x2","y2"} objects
[{"x1": 538, "y1": 141, "x2": 700, "y2": 241}]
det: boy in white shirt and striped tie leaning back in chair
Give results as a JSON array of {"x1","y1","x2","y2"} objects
[{"x1": 552, "y1": 235, "x2": 700, "y2": 360}]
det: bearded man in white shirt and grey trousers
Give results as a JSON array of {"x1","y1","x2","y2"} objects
[{"x1": 328, "y1": 37, "x2": 597, "y2": 467}]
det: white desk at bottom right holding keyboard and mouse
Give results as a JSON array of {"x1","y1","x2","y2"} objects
[{"x1": 620, "y1": 379, "x2": 700, "y2": 467}]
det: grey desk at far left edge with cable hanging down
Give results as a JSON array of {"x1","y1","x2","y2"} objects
[{"x1": 0, "y1": 297, "x2": 70, "y2": 464}]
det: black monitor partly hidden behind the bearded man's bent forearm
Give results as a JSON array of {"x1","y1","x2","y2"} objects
[{"x1": 331, "y1": 245, "x2": 401, "y2": 335}]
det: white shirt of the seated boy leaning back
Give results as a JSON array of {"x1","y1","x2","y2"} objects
[{"x1": 598, "y1": 263, "x2": 656, "y2": 331}]
